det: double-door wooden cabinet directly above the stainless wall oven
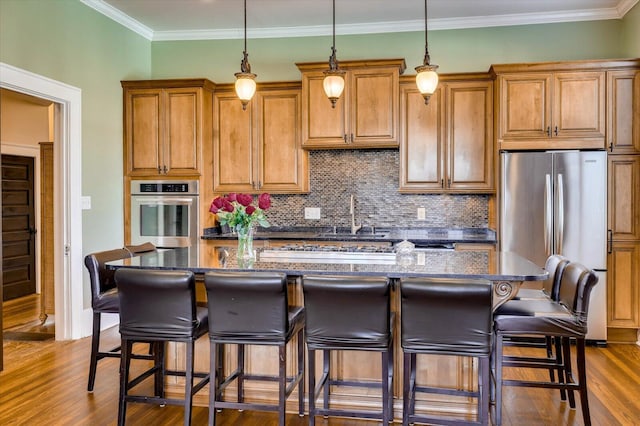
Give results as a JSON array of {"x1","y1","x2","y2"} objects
[{"x1": 122, "y1": 79, "x2": 215, "y2": 177}]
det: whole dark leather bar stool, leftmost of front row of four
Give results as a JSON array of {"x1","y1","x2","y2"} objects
[{"x1": 115, "y1": 268, "x2": 209, "y2": 425}]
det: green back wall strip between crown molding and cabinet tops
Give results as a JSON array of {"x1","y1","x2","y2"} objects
[{"x1": 152, "y1": 19, "x2": 624, "y2": 83}]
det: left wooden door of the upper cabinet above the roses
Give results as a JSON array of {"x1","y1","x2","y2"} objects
[{"x1": 213, "y1": 92, "x2": 258, "y2": 192}]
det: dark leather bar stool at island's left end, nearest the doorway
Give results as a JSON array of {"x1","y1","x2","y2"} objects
[{"x1": 84, "y1": 248, "x2": 131, "y2": 392}]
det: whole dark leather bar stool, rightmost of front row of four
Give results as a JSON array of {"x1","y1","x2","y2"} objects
[{"x1": 400, "y1": 278, "x2": 492, "y2": 425}]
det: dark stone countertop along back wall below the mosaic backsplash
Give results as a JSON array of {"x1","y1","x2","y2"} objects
[{"x1": 201, "y1": 227, "x2": 496, "y2": 247}]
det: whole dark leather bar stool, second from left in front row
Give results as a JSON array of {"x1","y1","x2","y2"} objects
[{"x1": 204, "y1": 272, "x2": 305, "y2": 426}]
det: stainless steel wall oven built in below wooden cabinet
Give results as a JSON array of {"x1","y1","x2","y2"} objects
[{"x1": 131, "y1": 180, "x2": 199, "y2": 248}]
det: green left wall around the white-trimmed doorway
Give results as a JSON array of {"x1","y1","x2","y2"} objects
[{"x1": 0, "y1": 0, "x2": 151, "y2": 260}]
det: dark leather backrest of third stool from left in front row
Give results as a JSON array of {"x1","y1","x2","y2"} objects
[{"x1": 302, "y1": 275, "x2": 391, "y2": 350}]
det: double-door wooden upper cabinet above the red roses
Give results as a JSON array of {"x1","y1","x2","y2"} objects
[{"x1": 212, "y1": 82, "x2": 309, "y2": 194}]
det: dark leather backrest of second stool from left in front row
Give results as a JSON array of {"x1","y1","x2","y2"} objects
[{"x1": 205, "y1": 272, "x2": 290, "y2": 344}]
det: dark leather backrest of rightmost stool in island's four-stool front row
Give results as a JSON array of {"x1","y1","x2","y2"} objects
[{"x1": 400, "y1": 278, "x2": 492, "y2": 356}]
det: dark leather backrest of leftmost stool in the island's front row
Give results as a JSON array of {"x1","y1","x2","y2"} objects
[{"x1": 115, "y1": 268, "x2": 200, "y2": 341}]
